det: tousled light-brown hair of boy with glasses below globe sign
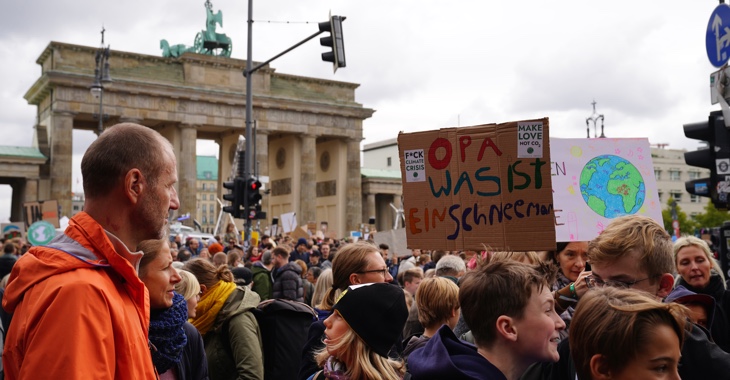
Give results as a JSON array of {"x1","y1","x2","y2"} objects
[{"x1": 588, "y1": 215, "x2": 677, "y2": 284}]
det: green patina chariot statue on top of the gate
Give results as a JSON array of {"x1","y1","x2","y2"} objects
[{"x1": 160, "y1": 0, "x2": 233, "y2": 58}]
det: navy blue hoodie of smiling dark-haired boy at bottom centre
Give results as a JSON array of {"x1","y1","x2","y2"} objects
[{"x1": 408, "y1": 325, "x2": 507, "y2": 380}]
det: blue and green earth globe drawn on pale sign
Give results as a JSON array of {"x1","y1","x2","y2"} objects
[{"x1": 580, "y1": 154, "x2": 646, "y2": 218}]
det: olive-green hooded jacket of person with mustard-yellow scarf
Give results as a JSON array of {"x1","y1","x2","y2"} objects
[{"x1": 203, "y1": 287, "x2": 264, "y2": 380}]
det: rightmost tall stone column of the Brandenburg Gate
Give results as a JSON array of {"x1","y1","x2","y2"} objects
[{"x1": 341, "y1": 138, "x2": 362, "y2": 236}]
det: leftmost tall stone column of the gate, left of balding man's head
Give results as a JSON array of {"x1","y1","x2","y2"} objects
[{"x1": 50, "y1": 111, "x2": 74, "y2": 218}]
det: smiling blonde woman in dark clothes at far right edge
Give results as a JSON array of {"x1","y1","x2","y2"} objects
[{"x1": 674, "y1": 236, "x2": 730, "y2": 352}]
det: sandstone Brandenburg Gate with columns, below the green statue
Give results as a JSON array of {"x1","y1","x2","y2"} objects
[{"x1": 19, "y1": 42, "x2": 374, "y2": 233}]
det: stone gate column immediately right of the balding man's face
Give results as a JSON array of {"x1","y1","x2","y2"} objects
[{"x1": 177, "y1": 124, "x2": 198, "y2": 227}]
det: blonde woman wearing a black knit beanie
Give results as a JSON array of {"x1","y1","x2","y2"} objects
[{"x1": 309, "y1": 283, "x2": 408, "y2": 380}]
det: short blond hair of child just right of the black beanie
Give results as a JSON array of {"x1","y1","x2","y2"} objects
[{"x1": 416, "y1": 277, "x2": 459, "y2": 328}]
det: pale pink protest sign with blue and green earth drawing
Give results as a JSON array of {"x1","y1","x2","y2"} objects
[{"x1": 550, "y1": 138, "x2": 663, "y2": 241}]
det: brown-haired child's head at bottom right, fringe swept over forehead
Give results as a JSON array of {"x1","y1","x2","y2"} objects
[{"x1": 569, "y1": 287, "x2": 688, "y2": 380}]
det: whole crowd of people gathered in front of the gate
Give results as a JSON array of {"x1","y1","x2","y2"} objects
[{"x1": 0, "y1": 123, "x2": 730, "y2": 380}]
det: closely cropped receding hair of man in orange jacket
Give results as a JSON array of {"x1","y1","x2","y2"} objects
[{"x1": 81, "y1": 123, "x2": 174, "y2": 198}]
